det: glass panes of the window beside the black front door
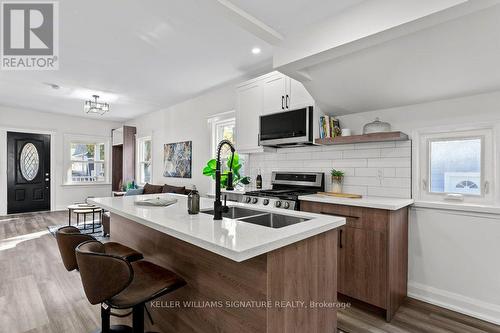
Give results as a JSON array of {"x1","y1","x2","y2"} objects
[{"x1": 70, "y1": 142, "x2": 106, "y2": 183}]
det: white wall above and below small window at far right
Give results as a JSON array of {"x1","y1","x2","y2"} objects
[{"x1": 340, "y1": 92, "x2": 500, "y2": 324}]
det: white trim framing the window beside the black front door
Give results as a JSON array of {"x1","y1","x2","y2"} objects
[{"x1": 63, "y1": 134, "x2": 112, "y2": 186}]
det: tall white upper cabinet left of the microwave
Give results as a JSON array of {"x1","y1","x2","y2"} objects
[{"x1": 236, "y1": 81, "x2": 263, "y2": 153}]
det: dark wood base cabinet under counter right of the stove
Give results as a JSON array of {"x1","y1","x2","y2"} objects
[{"x1": 300, "y1": 201, "x2": 408, "y2": 321}]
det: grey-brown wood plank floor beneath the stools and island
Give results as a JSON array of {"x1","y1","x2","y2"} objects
[{"x1": 0, "y1": 212, "x2": 500, "y2": 333}]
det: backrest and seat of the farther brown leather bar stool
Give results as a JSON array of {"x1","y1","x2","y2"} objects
[{"x1": 56, "y1": 226, "x2": 143, "y2": 271}]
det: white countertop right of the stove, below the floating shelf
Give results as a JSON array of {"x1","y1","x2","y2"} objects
[{"x1": 299, "y1": 194, "x2": 414, "y2": 210}]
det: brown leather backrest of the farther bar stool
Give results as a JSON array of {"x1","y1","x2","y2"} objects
[{"x1": 56, "y1": 226, "x2": 95, "y2": 271}]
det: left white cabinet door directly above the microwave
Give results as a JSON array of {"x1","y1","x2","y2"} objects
[{"x1": 263, "y1": 73, "x2": 290, "y2": 114}]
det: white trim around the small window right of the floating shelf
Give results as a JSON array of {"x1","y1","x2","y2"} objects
[{"x1": 413, "y1": 125, "x2": 497, "y2": 205}]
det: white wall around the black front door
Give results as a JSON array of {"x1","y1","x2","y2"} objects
[{"x1": 0, "y1": 106, "x2": 121, "y2": 215}]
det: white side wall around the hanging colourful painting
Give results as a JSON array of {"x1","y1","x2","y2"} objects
[{"x1": 127, "y1": 84, "x2": 236, "y2": 195}]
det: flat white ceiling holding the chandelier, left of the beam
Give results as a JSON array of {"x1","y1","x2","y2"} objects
[{"x1": 0, "y1": 0, "x2": 278, "y2": 120}]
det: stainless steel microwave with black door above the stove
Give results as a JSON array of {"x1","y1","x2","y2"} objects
[{"x1": 259, "y1": 106, "x2": 314, "y2": 147}]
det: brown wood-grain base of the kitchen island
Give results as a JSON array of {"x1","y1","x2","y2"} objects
[{"x1": 111, "y1": 214, "x2": 339, "y2": 333}]
